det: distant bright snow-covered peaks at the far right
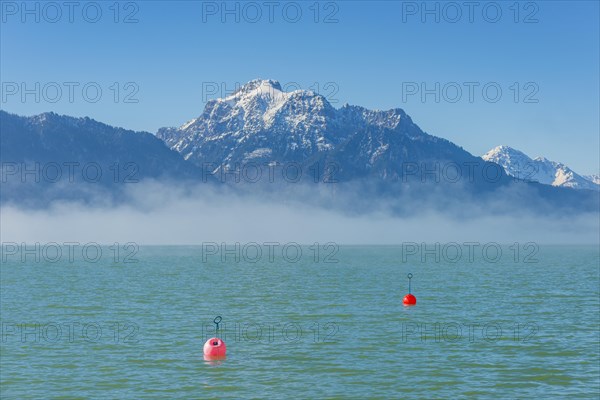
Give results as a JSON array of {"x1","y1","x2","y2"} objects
[{"x1": 481, "y1": 146, "x2": 600, "y2": 190}]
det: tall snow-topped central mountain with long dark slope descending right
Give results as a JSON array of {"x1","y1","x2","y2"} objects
[{"x1": 157, "y1": 79, "x2": 598, "y2": 214}]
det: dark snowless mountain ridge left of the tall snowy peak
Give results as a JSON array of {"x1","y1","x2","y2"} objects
[{"x1": 0, "y1": 110, "x2": 200, "y2": 205}]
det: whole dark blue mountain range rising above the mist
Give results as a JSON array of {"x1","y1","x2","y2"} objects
[{"x1": 0, "y1": 80, "x2": 599, "y2": 213}]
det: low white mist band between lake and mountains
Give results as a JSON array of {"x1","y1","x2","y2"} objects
[{"x1": 0, "y1": 181, "x2": 600, "y2": 245}]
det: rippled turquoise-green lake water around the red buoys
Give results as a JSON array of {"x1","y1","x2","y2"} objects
[{"x1": 0, "y1": 245, "x2": 600, "y2": 399}]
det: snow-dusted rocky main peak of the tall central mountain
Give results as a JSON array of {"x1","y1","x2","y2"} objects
[{"x1": 157, "y1": 80, "x2": 342, "y2": 163}]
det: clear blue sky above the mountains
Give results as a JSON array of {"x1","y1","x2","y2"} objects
[{"x1": 0, "y1": 1, "x2": 600, "y2": 174}]
